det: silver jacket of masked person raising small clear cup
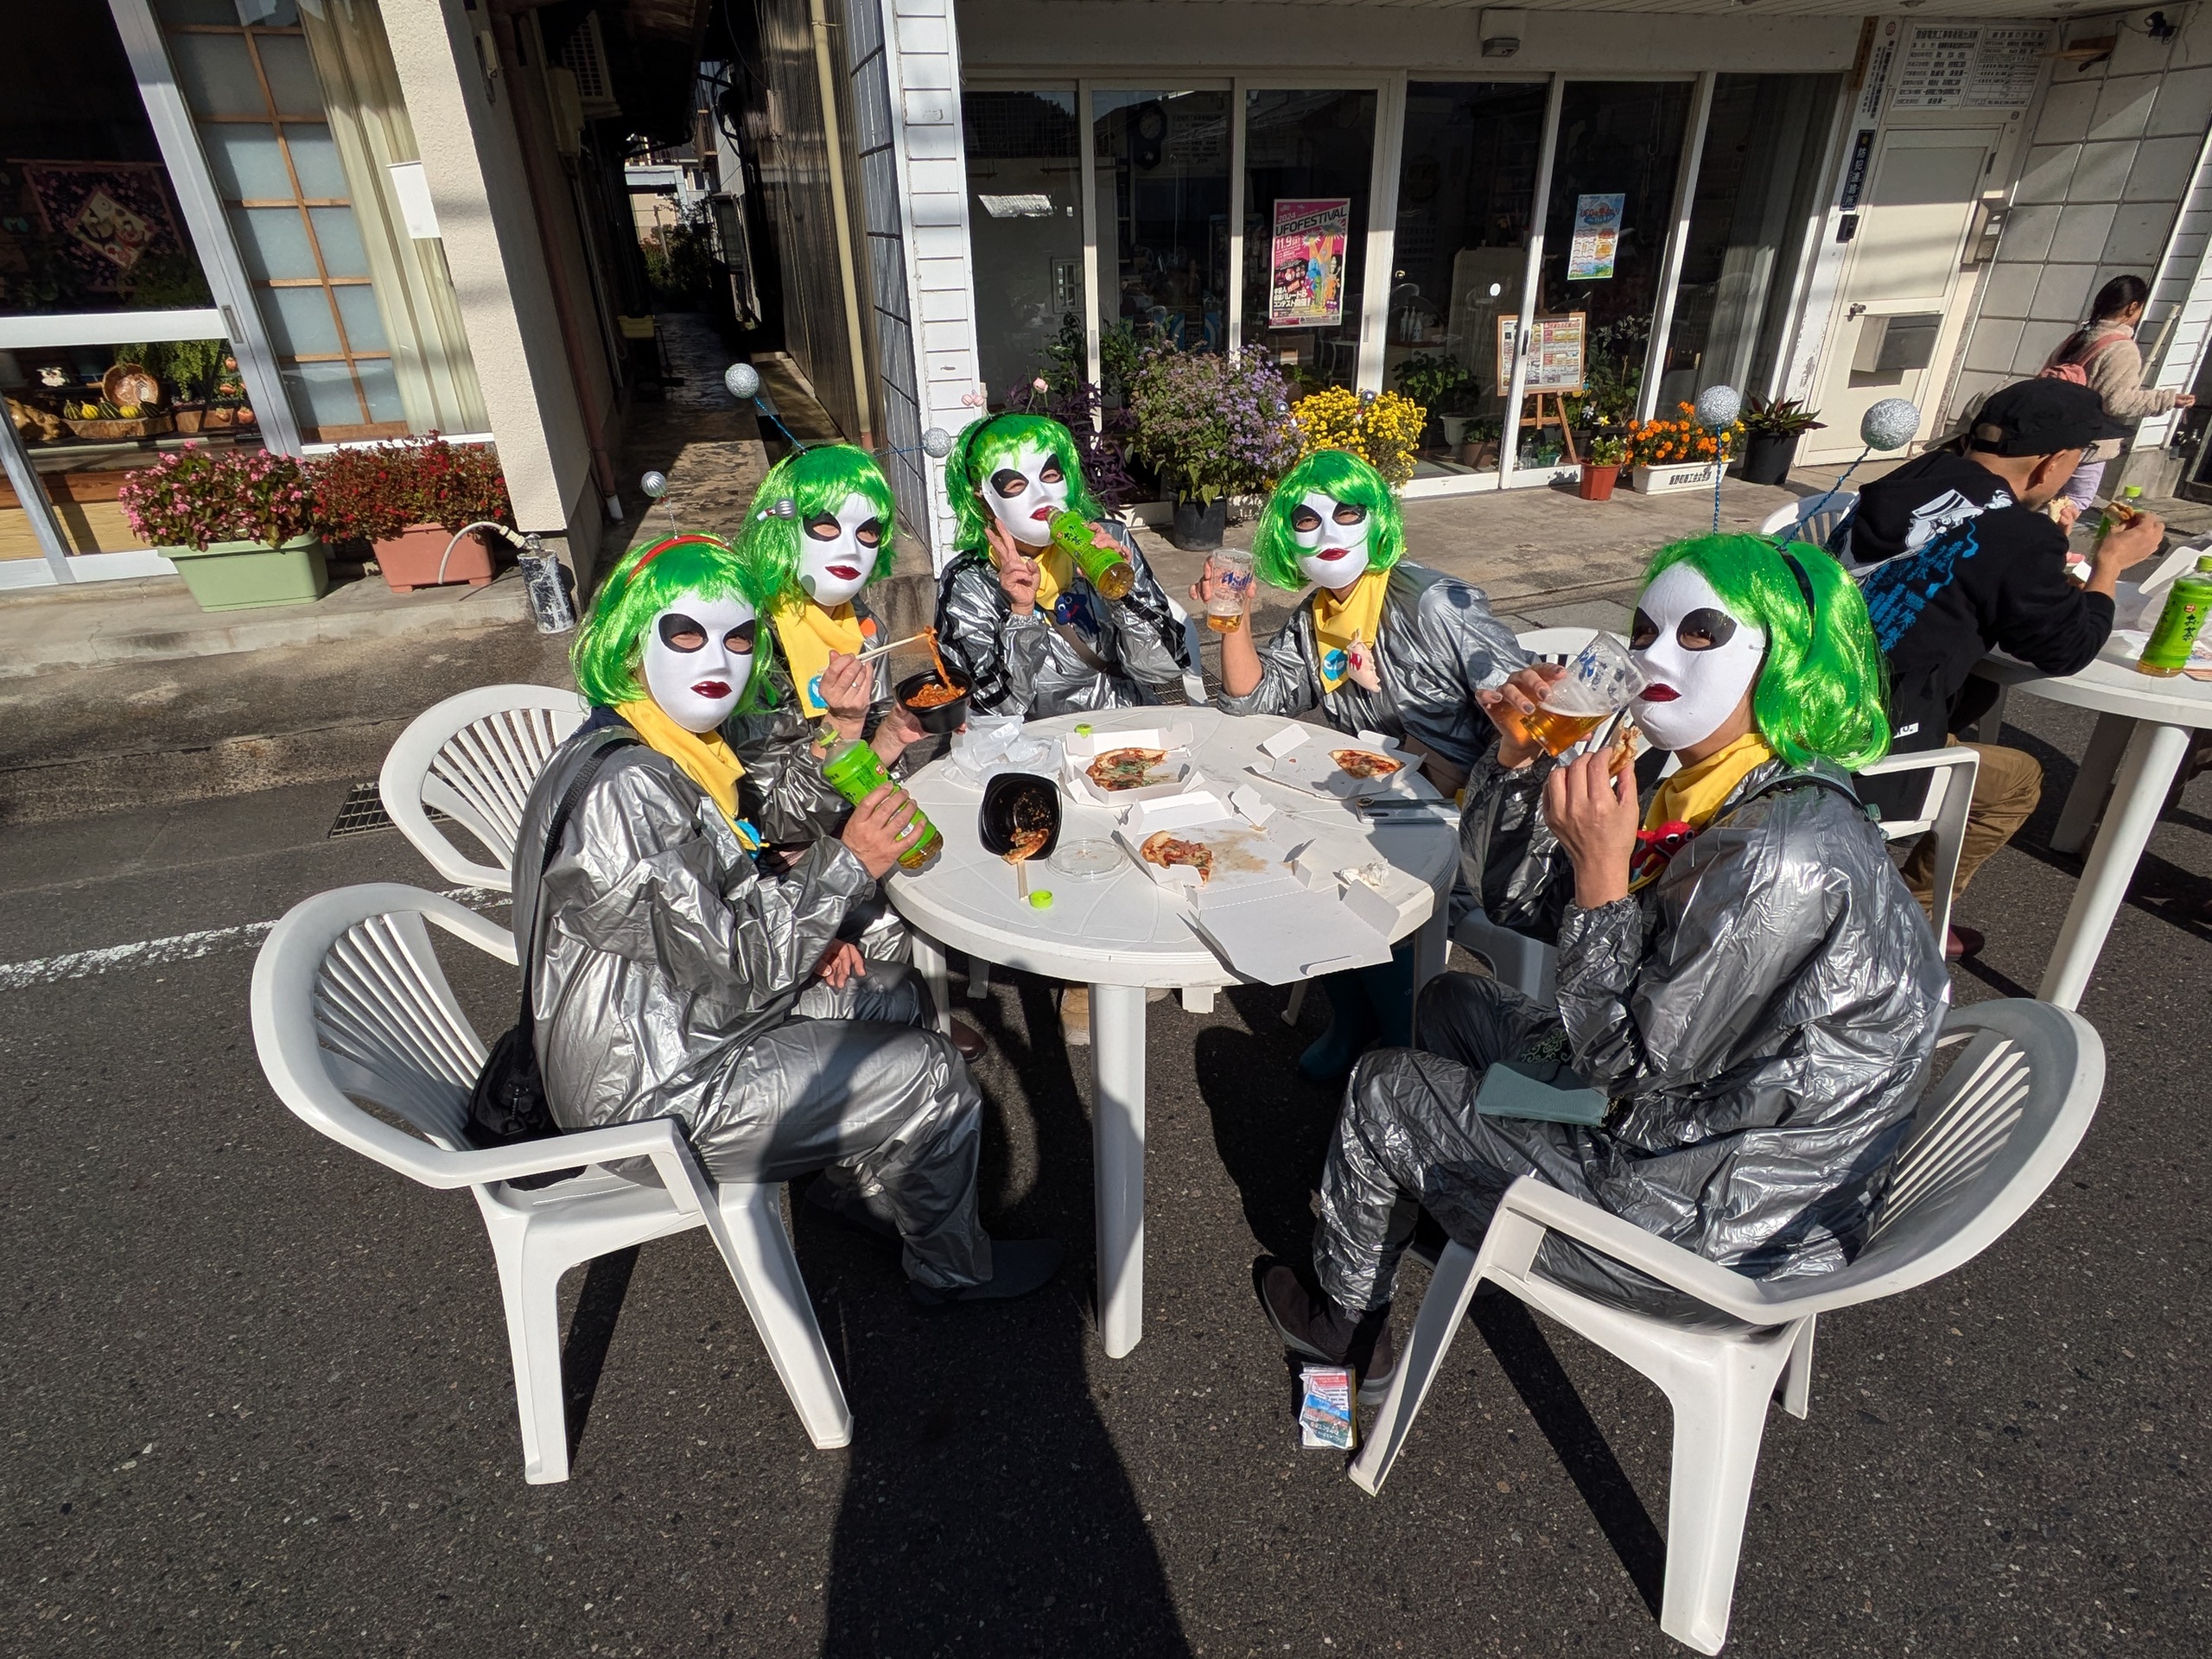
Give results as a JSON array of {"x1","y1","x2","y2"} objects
[{"x1": 1217, "y1": 560, "x2": 1529, "y2": 772}]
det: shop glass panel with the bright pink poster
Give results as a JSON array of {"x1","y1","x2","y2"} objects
[{"x1": 1243, "y1": 91, "x2": 1376, "y2": 387}]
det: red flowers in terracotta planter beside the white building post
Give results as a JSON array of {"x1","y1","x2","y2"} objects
[{"x1": 312, "y1": 434, "x2": 515, "y2": 593}]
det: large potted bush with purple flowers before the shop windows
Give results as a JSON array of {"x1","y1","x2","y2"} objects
[{"x1": 1128, "y1": 345, "x2": 1292, "y2": 553}]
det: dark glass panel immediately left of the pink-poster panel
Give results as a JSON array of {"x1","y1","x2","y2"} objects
[{"x1": 1090, "y1": 91, "x2": 1230, "y2": 376}]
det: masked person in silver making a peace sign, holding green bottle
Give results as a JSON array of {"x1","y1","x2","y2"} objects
[{"x1": 938, "y1": 414, "x2": 1192, "y2": 719}]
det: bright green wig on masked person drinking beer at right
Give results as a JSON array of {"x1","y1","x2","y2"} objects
[{"x1": 1643, "y1": 533, "x2": 1889, "y2": 772}]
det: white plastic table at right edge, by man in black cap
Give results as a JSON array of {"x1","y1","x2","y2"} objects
[{"x1": 1974, "y1": 639, "x2": 2212, "y2": 1008}]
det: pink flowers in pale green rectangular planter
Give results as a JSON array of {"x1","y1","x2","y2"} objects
[{"x1": 115, "y1": 445, "x2": 329, "y2": 611}]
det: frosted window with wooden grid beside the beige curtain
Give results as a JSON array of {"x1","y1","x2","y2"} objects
[{"x1": 159, "y1": 0, "x2": 407, "y2": 442}]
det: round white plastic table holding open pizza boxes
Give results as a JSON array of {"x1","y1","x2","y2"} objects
[{"x1": 887, "y1": 708, "x2": 1458, "y2": 1358}]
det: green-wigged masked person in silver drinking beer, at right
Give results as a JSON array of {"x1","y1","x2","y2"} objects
[{"x1": 1259, "y1": 536, "x2": 1948, "y2": 1398}]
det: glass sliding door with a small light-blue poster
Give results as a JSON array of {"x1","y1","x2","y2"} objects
[{"x1": 1517, "y1": 79, "x2": 1692, "y2": 467}]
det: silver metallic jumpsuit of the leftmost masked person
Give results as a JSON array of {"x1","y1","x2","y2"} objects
[{"x1": 515, "y1": 726, "x2": 991, "y2": 1289}]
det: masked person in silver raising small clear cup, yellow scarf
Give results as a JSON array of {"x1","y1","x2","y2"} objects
[{"x1": 1190, "y1": 449, "x2": 1529, "y2": 1082}]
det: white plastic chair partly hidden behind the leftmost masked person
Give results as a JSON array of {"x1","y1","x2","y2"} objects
[{"x1": 376, "y1": 686, "x2": 591, "y2": 893}]
